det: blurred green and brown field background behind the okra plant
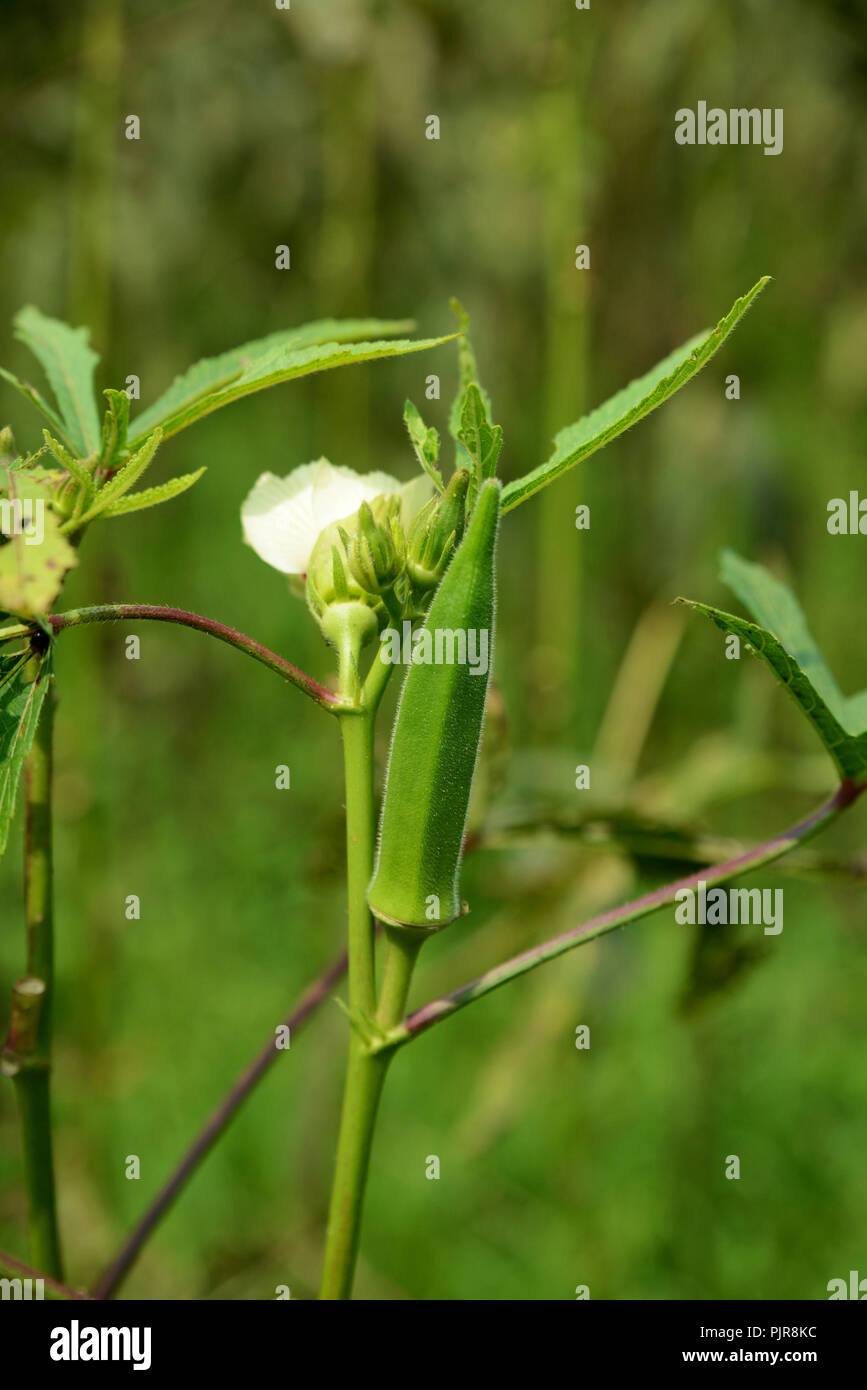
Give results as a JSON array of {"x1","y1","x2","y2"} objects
[{"x1": 0, "y1": 0, "x2": 867, "y2": 1300}]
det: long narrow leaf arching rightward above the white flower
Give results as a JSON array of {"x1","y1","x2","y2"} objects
[{"x1": 129, "y1": 318, "x2": 413, "y2": 442}]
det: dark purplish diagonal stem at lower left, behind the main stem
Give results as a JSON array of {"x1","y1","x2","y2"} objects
[{"x1": 93, "y1": 951, "x2": 346, "y2": 1298}]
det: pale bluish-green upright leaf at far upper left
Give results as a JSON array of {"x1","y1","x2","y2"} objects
[{"x1": 13, "y1": 304, "x2": 100, "y2": 455}]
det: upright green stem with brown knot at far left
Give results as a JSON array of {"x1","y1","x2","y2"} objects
[{"x1": 14, "y1": 678, "x2": 63, "y2": 1279}]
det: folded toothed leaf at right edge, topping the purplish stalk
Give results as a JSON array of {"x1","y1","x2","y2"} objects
[{"x1": 677, "y1": 550, "x2": 867, "y2": 781}]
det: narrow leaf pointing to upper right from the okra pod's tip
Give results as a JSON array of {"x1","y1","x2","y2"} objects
[{"x1": 503, "y1": 275, "x2": 770, "y2": 512}]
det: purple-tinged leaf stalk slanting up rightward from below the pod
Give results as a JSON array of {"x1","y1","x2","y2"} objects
[{"x1": 371, "y1": 781, "x2": 864, "y2": 1055}]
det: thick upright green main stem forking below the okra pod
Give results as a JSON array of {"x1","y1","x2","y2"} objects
[{"x1": 320, "y1": 709, "x2": 421, "y2": 1300}]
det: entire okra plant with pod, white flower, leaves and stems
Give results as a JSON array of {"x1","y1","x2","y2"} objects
[{"x1": 0, "y1": 279, "x2": 867, "y2": 1300}]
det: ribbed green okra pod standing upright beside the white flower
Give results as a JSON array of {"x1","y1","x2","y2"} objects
[{"x1": 368, "y1": 480, "x2": 500, "y2": 930}]
